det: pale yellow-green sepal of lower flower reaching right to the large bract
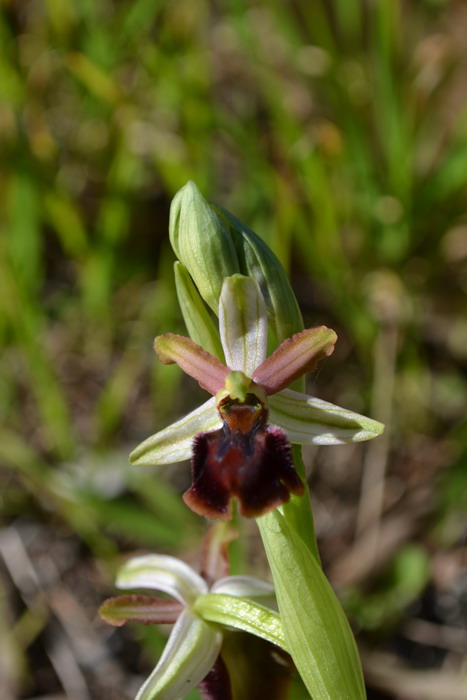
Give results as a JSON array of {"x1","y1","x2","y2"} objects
[{"x1": 193, "y1": 593, "x2": 287, "y2": 651}]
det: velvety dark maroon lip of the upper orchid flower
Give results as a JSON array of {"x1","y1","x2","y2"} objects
[{"x1": 183, "y1": 416, "x2": 304, "y2": 520}]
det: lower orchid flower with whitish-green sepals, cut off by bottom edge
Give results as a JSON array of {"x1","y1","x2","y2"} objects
[{"x1": 99, "y1": 531, "x2": 285, "y2": 700}]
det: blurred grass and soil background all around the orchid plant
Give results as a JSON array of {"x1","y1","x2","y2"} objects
[{"x1": 0, "y1": 0, "x2": 467, "y2": 700}]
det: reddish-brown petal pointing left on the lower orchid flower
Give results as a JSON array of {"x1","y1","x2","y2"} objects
[{"x1": 99, "y1": 594, "x2": 183, "y2": 627}]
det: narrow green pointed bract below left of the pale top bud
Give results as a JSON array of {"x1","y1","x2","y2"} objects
[{"x1": 174, "y1": 260, "x2": 224, "y2": 362}]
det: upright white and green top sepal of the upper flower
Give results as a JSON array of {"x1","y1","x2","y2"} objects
[{"x1": 219, "y1": 275, "x2": 268, "y2": 377}]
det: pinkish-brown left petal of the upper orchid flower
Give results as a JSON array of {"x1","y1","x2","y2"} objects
[{"x1": 154, "y1": 333, "x2": 229, "y2": 395}]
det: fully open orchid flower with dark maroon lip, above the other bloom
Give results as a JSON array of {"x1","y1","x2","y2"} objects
[{"x1": 130, "y1": 274, "x2": 383, "y2": 519}]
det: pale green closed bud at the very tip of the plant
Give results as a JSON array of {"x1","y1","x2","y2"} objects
[{"x1": 169, "y1": 181, "x2": 240, "y2": 314}]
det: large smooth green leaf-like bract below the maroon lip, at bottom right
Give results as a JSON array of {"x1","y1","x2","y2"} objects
[{"x1": 257, "y1": 509, "x2": 366, "y2": 700}]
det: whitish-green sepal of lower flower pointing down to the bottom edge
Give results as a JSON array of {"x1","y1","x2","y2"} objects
[{"x1": 135, "y1": 610, "x2": 222, "y2": 700}]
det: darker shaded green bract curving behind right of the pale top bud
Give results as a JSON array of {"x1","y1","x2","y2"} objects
[{"x1": 212, "y1": 204, "x2": 303, "y2": 343}]
